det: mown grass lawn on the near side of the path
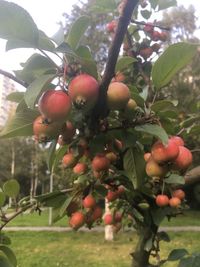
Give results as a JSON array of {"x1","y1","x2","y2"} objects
[{"x1": 5, "y1": 232, "x2": 200, "y2": 267}]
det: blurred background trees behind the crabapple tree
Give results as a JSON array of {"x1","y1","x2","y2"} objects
[{"x1": 0, "y1": 0, "x2": 200, "y2": 207}]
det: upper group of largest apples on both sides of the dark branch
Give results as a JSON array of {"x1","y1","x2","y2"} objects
[{"x1": 33, "y1": 74, "x2": 136, "y2": 143}]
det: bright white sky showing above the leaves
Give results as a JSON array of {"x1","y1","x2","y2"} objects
[{"x1": 0, "y1": 0, "x2": 200, "y2": 74}]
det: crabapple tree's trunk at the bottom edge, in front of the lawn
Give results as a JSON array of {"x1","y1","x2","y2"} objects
[{"x1": 131, "y1": 227, "x2": 157, "y2": 267}]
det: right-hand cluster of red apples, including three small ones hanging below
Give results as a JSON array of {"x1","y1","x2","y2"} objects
[{"x1": 144, "y1": 136, "x2": 192, "y2": 207}]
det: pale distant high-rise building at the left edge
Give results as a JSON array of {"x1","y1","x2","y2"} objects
[{"x1": 0, "y1": 75, "x2": 16, "y2": 129}]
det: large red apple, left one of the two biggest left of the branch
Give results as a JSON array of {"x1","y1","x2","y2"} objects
[{"x1": 38, "y1": 90, "x2": 71, "y2": 122}]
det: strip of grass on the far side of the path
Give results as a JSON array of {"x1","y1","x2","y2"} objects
[{"x1": 8, "y1": 210, "x2": 200, "y2": 227}]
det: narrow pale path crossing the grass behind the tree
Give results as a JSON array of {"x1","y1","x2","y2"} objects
[{"x1": 4, "y1": 226, "x2": 200, "y2": 232}]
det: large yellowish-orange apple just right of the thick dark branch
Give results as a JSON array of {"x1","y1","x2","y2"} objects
[{"x1": 107, "y1": 82, "x2": 131, "y2": 110}]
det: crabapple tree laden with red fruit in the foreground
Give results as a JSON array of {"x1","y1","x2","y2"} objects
[{"x1": 0, "y1": 0, "x2": 199, "y2": 267}]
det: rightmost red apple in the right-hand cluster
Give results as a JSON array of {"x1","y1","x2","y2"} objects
[{"x1": 174, "y1": 146, "x2": 192, "y2": 170}]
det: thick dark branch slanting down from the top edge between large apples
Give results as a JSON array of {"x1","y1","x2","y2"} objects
[{"x1": 92, "y1": 0, "x2": 139, "y2": 122}]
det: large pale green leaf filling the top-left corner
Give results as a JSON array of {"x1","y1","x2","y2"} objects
[{"x1": 0, "y1": 0, "x2": 39, "y2": 46}]
